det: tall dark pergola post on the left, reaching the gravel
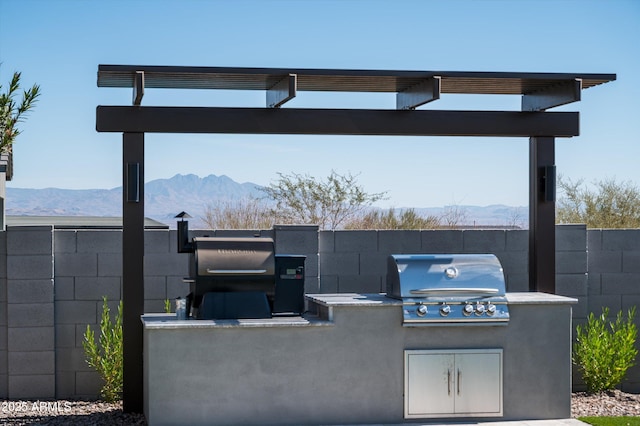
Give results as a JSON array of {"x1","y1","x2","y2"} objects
[{"x1": 122, "y1": 133, "x2": 144, "y2": 413}]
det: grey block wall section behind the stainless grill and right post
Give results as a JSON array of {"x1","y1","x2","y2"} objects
[{"x1": 319, "y1": 225, "x2": 587, "y2": 296}]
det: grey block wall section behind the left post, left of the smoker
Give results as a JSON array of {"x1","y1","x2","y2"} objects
[{"x1": 54, "y1": 229, "x2": 188, "y2": 398}]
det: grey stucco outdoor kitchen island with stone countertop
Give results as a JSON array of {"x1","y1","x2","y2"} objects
[{"x1": 142, "y1": 293, "x2": 577, "y2": 425}]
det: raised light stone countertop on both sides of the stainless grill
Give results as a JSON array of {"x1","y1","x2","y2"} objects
[{"x1": 306, "y1": 292, "x2": 578, "y2": 307}]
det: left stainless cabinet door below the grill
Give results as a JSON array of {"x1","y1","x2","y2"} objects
[{"x1": 404, "y1": 351, "x2": 455, "y2": 418}]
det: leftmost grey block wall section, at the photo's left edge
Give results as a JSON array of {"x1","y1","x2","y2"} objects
[{"x1": 0, "y1": 226, "x2": 56, "y2": 399}]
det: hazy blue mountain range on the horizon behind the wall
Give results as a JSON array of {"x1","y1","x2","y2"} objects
[{"x1": 6, "y1": 174, "x2": 528, "y2": 229}]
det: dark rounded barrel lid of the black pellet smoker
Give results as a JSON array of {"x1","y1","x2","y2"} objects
[{"x1": 193, "y1": 237, "x2": 275, "y2": 277}]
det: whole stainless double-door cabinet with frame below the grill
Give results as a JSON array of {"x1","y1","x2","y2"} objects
[{"x1": 404, "y1": 349, "x2": 502, "y2": 419}]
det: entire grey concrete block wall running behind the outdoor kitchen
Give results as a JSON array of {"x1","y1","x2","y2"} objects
[{"x1": 0, "y1": 225, "x2": 640, "y2": 399}]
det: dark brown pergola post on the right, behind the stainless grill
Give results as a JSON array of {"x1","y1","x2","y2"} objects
[{"x1": 529, "y1": 137, "x2": 556, "y2": 294}]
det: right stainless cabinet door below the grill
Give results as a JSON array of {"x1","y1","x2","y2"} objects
[{"x1": 455, "y1": 352, "x2": 502, "y2": 416}]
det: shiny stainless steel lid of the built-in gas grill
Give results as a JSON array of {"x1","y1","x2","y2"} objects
[{"x1": 387, "y1": 254, "x2": 505, "y2": 299}]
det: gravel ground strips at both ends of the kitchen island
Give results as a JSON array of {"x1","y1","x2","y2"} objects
[{"x1": 0, "y1": 390, "x2": 640, "y2": 426}]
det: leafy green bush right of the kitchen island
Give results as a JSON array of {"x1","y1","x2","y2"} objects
[{"x1": 573, "y1": 307, "x2": 638, "y2": 393}]
